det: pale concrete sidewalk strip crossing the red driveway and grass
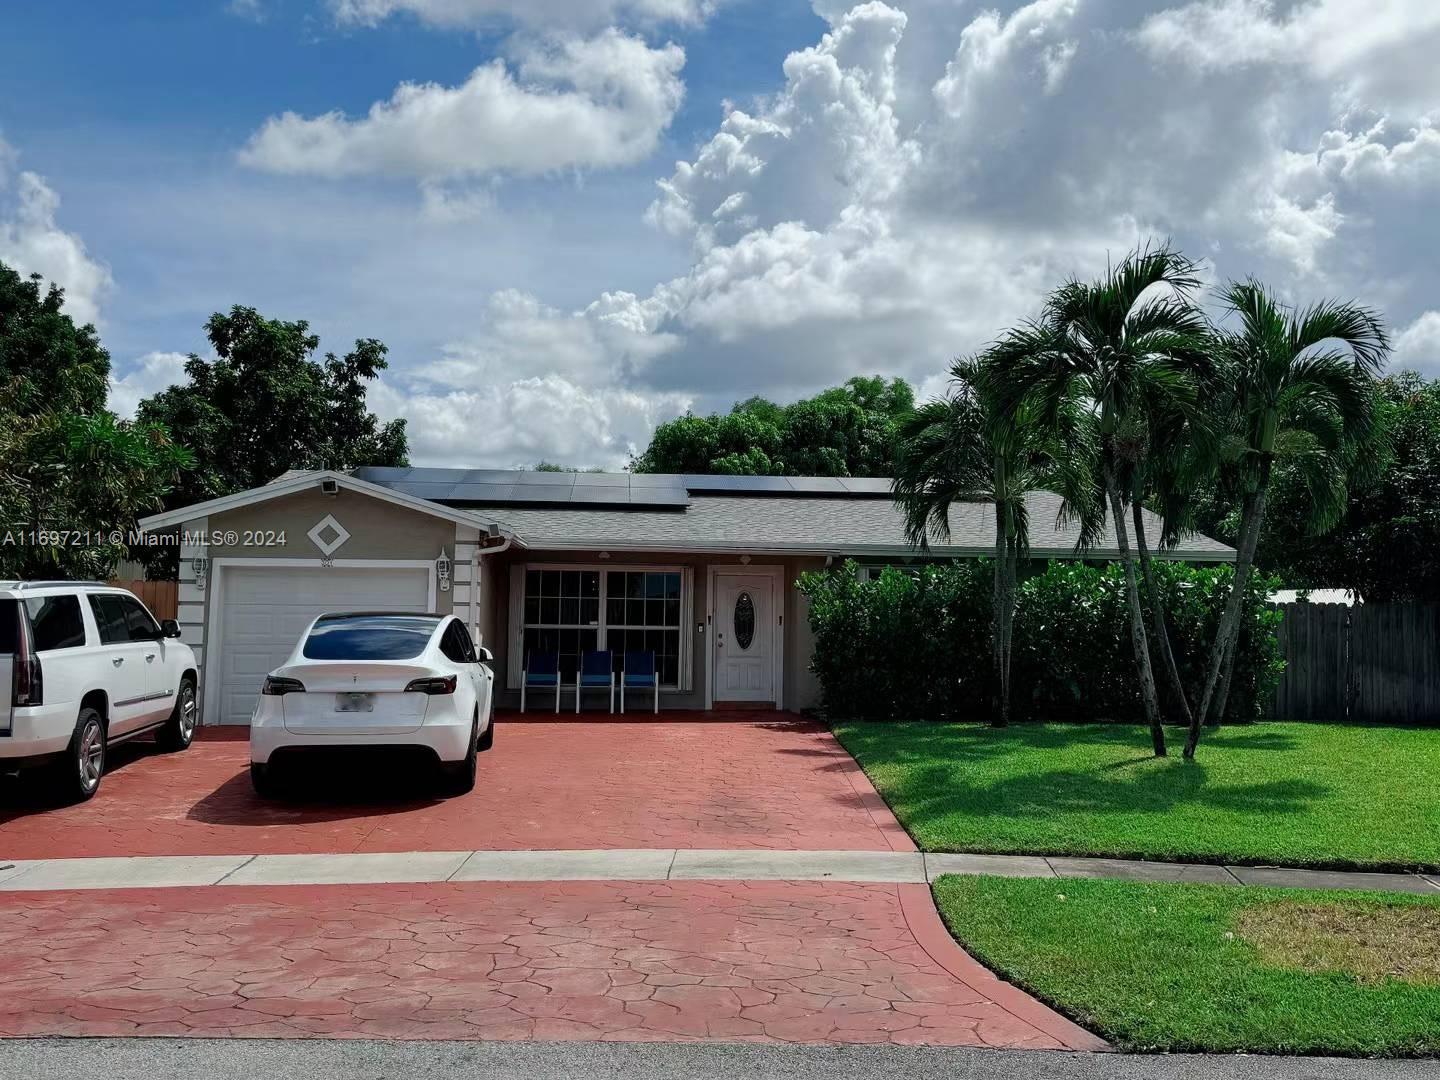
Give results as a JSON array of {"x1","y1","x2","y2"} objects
[{"x1": 0, "y1": 848, "x2": 1440, "y2": 897}]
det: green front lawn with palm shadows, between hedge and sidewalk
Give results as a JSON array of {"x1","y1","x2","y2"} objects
[{"x1": 835, "y1": 723, "x2": 1440, "y2": 868}]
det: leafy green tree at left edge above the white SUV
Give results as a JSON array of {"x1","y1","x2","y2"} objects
[{"x1": 0, "y1": 264, "x2": 192, "y2": 577}]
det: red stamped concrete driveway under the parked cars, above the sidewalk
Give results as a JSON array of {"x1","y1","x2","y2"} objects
[{"x1": 0, "y1": 713, "x2": 914, "y2": 858}]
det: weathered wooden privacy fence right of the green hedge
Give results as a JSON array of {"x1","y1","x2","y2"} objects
[{"x1": 1274, "y1": 603, "x2": 1440, "y2": 724}]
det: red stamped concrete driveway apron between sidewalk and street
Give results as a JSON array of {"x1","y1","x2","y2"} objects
[{"x1": 0, "y1": 881, "x2": 1103, "y2": 1050}]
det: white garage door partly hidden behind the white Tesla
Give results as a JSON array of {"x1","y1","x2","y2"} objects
[{"x1": 206, "y1": 566, "x2": 429, "y2": 724}]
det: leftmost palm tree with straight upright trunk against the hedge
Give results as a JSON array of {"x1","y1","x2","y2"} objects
[{"x1": 894, "y1": 360, "x2": 1054, "y2": 727}]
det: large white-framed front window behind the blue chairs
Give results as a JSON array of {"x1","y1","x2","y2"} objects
[{"x1": 521, "y1": 566, "x2": 684, "y2": 690}]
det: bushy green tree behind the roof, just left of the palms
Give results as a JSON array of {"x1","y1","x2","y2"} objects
[{"x1": 631, "y1": 376, "x2": 914, "y2": 477}]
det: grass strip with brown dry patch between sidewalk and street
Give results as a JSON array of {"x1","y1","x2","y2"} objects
[{"x1": 935, "y1": 877, "x2": 1440, "y2": 1056}]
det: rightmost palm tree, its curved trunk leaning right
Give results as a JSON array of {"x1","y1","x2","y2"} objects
[{"x1": 1185, "y1": 288, "x2": 1390, "y2": 759}]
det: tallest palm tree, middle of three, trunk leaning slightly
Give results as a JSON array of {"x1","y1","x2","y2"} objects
[{"x1": 984, "y1": 245, "x2": 1211, "y2": 757}]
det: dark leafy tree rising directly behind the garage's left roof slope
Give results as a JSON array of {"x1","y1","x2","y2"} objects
[{"x1": 140, "y1": 307, "x2": 408, "y2": 507}]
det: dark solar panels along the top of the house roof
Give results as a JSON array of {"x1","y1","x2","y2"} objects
[{"x1": 354, "y1": 467, "x2": 890, "y2": 507}]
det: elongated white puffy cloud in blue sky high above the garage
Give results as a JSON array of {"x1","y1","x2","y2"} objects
[{"x1": 240, "y1": 29, "x2": 685, "y2": 180}]
